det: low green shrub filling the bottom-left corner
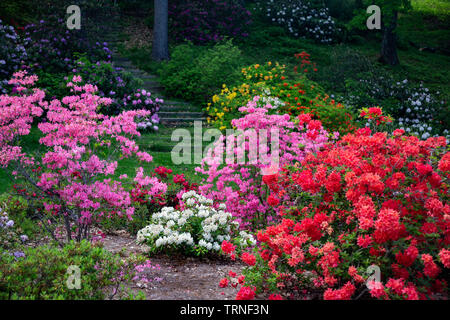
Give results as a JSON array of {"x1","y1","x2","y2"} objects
[{"x1": 0, "y1": 241, "x2": 143, "y2": 300}]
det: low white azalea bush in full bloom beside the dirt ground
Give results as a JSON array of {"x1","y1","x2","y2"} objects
[{"x1": 137, "y1": 191, "x2": 256, "y2": 256}]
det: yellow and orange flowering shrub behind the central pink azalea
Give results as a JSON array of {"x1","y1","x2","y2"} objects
[{"x1": 206, "y1": 53, "x2": 355, "y2": 134}]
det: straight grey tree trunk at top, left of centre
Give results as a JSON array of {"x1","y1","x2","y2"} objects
[{"x1": 152, "y1": 0, "x2": 169, "y2": 61}]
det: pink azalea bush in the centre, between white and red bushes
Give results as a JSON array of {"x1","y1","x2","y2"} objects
[{"x1": 196, "y1": 96, "x2": 337, "y2": 228}]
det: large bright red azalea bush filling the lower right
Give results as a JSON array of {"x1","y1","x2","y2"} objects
[{"x1": 225, "y1": 113, "x2": 450, "y2": 299}]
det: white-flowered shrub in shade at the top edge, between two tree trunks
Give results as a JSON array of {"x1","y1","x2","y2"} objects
[{"x1": 256, "y1": 0, "x2": 337, "y2": 43}]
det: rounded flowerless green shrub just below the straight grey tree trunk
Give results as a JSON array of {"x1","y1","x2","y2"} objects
[{"x1": 160, "y1": 40, "x2": 242, "y2": 103}]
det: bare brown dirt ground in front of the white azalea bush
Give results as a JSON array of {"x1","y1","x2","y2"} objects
[{"x1": 103, "y1": 234, "x2": 243, "y2": 300}]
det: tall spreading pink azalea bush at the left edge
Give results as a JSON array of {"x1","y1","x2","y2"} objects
[{"x1": 0, "y1": 71, "x2": 167, "y2": 241}]
